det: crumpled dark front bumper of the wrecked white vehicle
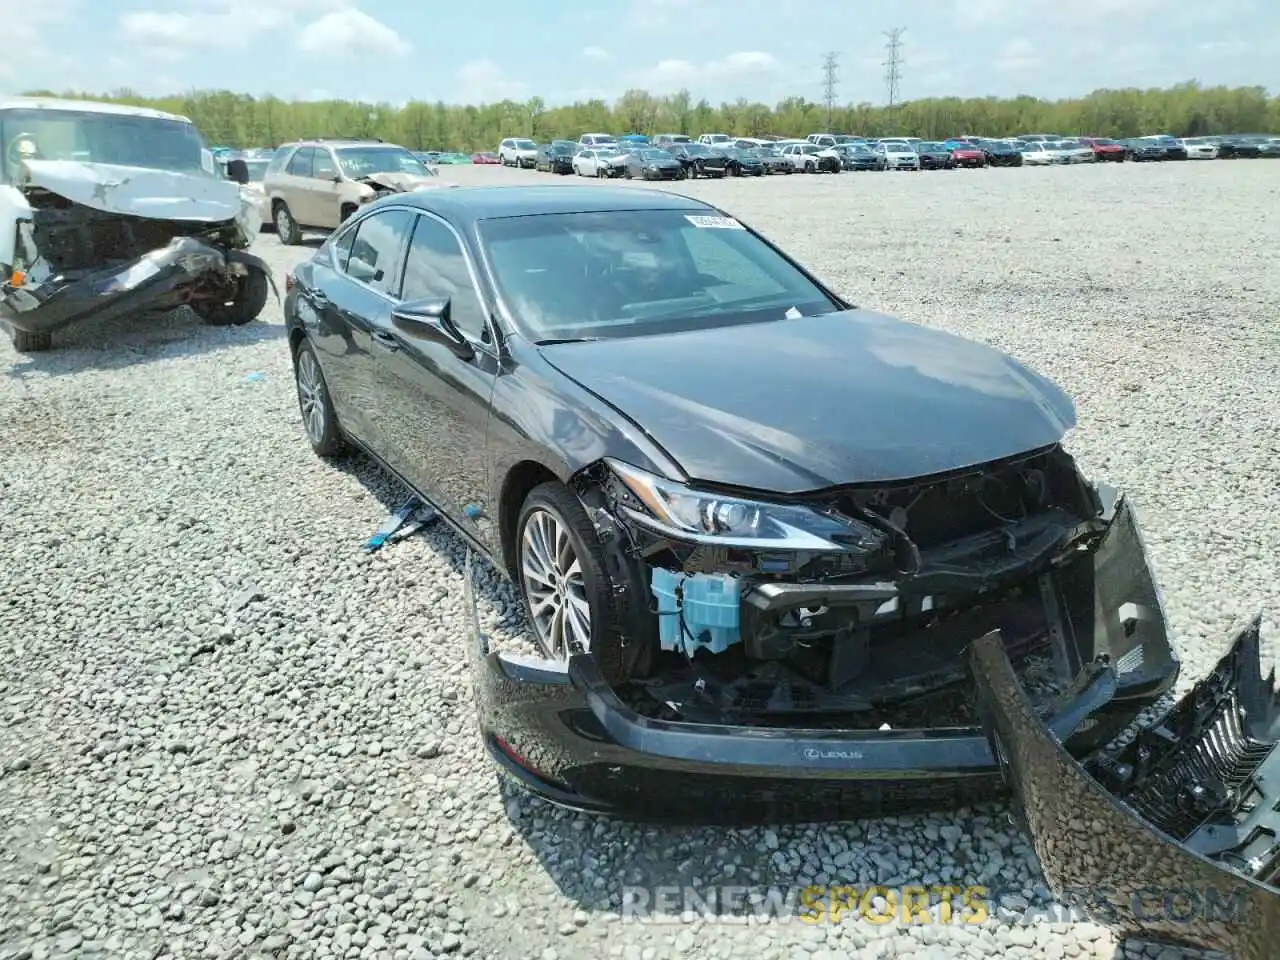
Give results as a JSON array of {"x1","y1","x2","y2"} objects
[{"x1": 0, "y1": 237, "x2": 264, "y2": 333}]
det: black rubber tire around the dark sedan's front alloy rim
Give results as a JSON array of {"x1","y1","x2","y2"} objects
[{"x1": 515, "y1": 481, "x2": 653, "y2": 685}]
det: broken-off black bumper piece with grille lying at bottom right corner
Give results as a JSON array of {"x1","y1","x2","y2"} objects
[{"x1": 969, "y1": 618, "x2": 1280, "y2": 960}]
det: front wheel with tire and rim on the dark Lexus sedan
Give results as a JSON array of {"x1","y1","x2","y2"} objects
[{"x1": 516, "y1": 481, "x2": 644, "y2": 684}]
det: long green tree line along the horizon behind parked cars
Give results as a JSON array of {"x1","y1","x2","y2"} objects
[{"x1": 22, "y1": 81, "x2": 1280, "y2": 152}]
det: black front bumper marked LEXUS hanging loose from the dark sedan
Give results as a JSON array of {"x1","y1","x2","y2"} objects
[{"x1": 466, "y1": 496, "x2": 1178, "y2": 823}]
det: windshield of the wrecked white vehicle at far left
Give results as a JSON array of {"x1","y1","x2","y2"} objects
[{"x1": 0, "y1": 110, "x2": 215, "y2": 182}]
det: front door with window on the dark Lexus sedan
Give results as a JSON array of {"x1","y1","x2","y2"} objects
[{"x1": 375, "y1": 211, "x2": 498, "y2": 549}]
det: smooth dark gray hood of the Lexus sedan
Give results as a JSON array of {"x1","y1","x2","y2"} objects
[{"x1": 540, "y1": 310, "x2": 1075, "y2": 493}]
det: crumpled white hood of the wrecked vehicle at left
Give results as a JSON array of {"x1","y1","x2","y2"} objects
[{"x1": 23, "y1": 160, "x2": 261, "y2": 238}]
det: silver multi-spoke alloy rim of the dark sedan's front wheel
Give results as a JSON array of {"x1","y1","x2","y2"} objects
[{"x1": 520, "y1": 509, "x2": 591, "y2": 663}]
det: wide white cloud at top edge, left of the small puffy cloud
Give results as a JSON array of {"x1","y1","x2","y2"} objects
[{"x1": 119, "y1": 0, "x2": 344, "y2": 61}]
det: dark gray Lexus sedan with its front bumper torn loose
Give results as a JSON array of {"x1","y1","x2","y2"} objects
[{"x1": 285, "y1": 187, "x2": 1249, "y2": 860}]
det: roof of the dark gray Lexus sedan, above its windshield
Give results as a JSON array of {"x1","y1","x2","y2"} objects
[{"x1": 384, "y1": 186, "x2": 718, "y2": 224}]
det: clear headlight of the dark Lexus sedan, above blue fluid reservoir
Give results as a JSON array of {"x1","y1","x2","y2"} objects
[{"x1": 605, "y1": 460, "x2": 890, "y2": 553}]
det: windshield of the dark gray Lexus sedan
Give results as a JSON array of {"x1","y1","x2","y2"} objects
[{"x1": 479, "y1": 210, "x2": 837, "y2": 340}]
